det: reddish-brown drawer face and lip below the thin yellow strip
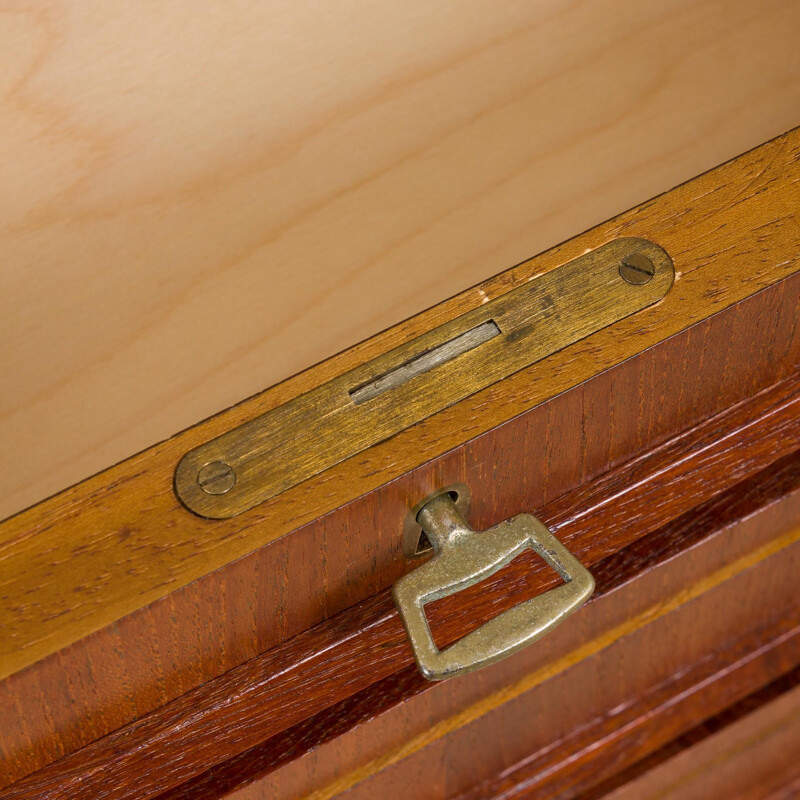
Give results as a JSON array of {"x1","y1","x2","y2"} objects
[{"x1": 334, "y1": 545, "x2": 800, "y2": 800}]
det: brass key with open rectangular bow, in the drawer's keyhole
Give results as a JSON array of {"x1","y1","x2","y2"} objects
[{"x1": 392, "y1": 493, "x2": 594, "y2": 681}]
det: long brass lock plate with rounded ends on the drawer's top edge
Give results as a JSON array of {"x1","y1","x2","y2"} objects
[{"x1": 175, "y1": 238, "x2": 674, "y2": 519}]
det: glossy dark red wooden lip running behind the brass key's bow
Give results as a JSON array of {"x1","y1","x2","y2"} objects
[{"x1": 2, "y1": 376, "x2": 800, "y2": 798}]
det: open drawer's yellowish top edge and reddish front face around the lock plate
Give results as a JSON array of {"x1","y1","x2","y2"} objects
[{"x1": 0, "y1": 134, "x2": 800, "y2": 788}]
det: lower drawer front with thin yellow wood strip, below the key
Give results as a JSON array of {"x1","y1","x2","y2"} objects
[{"x1": 197, "y1": 468, "x2": 800, "y2": 800}]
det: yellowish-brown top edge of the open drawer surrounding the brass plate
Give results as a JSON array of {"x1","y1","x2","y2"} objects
[{"x1": 0, "y1": 130, "x2": 800, "y2": 677}]
